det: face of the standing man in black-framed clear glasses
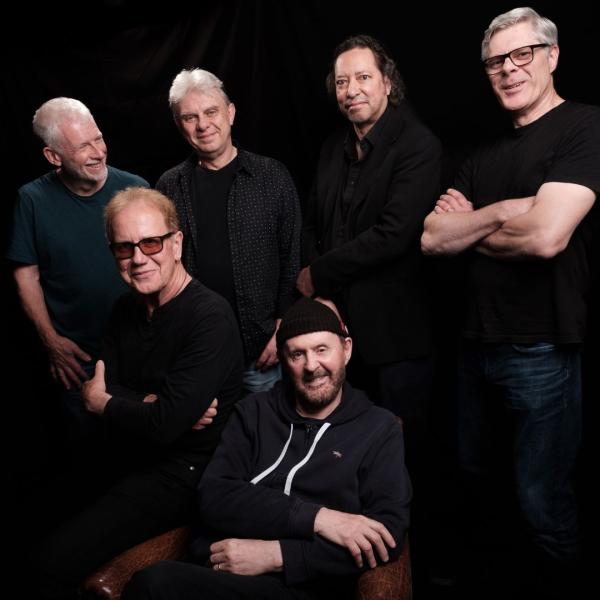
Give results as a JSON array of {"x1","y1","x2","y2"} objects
[{"x1": 488, "y1": 22, "x2": 562, "y2": 126}]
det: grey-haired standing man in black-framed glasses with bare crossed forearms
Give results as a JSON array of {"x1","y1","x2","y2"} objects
[{"x1": 422, "y1": 8, "x2": 600, "y2": 597}]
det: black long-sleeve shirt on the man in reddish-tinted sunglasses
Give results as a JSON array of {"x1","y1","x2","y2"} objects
[{"x1": 104, "y1": 280, "x2": 243, "y2": 466}]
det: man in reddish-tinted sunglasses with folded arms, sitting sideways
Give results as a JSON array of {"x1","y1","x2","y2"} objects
[{"x1": 38, "y1": 188, "x2": 243, "y2": 599}]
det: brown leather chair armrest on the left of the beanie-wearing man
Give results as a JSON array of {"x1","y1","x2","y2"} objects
[{"x1": 82, "y1": 527, "x2": 190, "y2": 600}]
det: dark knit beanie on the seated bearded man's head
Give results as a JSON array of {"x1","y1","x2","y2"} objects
[{"x1": 276, "y1": 298, "x2": 348, "y2": 349}]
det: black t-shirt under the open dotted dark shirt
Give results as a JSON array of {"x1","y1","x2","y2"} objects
[{"x1": 192, "y1": 156, "x2": 239, "y2": 321}]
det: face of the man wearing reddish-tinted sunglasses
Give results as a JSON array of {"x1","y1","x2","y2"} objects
[{"x1": 111, "y1": 200, "x2": 183, "y2": 305}]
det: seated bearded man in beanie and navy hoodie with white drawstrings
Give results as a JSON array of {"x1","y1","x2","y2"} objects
[{"x1": 122, "y1": 298, "x2": 411, "y2": 600}]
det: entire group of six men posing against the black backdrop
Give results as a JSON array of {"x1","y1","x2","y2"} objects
[{"x1": 8, "y1": 8, "x2": 600, "y2": 599}]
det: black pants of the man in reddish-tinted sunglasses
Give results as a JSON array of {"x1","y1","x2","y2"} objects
[{"x1": 36, "y1": 464, "x2": 200, "y2": 600}]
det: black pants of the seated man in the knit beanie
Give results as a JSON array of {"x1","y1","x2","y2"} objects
[{"x1": 121, "y1": 561, "x2": 322, "y2": 600}]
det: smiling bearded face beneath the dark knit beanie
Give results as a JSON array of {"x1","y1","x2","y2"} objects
[{"x1": 283, "y1": 331, "x2": 352, "y2": 419}]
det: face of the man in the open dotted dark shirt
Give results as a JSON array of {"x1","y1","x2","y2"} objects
[{"x1": 174, "y1": 88, "x2": 235, "y2": 161}]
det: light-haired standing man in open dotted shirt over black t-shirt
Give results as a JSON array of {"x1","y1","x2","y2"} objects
[{"x1": 156, "y1": 69, "x2": 300, "y2": 393}]
